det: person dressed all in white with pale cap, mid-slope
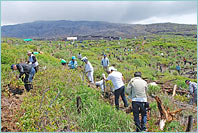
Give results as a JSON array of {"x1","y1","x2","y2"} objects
[{"x1": 81, "y1": 57, "x2": 94, "y2": 83}]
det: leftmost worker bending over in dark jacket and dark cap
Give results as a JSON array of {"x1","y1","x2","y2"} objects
[{"x1": 11, "y1": 63, "x2": 36, "y2": 91}]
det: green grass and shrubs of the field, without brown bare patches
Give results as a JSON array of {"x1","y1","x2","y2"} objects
[{"x1": 1, "y1": 36, "x2": 197, "y2": 132}]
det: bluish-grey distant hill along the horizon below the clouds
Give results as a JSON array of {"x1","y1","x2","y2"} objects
[{"x1": 1, "y1": 20, "x2": 197, "y2": 39}]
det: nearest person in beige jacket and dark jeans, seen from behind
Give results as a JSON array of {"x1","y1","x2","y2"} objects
[{"x1": 126, "y1": 72, "x2": 148, "y2": 132}]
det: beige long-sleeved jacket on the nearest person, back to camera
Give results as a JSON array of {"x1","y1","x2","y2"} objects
[{"x1": 126, "y1": 77, "x2": 147, "y2": 102}]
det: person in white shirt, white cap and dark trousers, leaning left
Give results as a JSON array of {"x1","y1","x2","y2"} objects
[{"x1": 103, "y1": 66, "x2": 128, "y2": 110}]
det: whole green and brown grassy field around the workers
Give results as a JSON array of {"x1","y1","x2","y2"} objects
[{"x1": 1, "y1": 36, "x2": 197, "y2": 132}]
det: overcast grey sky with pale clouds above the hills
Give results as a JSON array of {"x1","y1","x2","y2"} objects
[{"x1": 1, "y1": 1, "x2": 197, "y2": 25}]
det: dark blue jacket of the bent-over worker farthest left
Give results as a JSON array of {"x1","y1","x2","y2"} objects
[{"x1": 16, "y1": 63, "x2": 32, "y2": 78}]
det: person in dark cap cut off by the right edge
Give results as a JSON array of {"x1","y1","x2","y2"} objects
[{"x1": 185, "y1": 80, "x2": 197, "y2": 105}]
